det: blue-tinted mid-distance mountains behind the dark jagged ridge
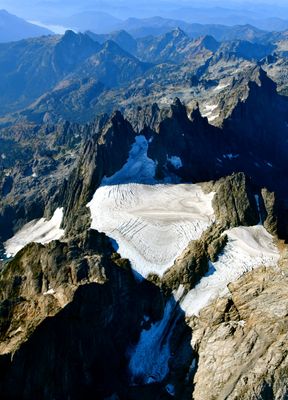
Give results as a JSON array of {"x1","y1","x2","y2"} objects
[{"x1": 0, "y1": 26, "x2": 288, "y2": 124}]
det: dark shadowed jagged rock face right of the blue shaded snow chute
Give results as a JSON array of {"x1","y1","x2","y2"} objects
[{"x1": 148, "y1": 99, "x2": 226, "y2": 182}]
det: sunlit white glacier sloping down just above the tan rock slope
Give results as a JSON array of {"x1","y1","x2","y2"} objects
[{"x1": 180, "y1": 225, "x2": 280, "y2": 316}]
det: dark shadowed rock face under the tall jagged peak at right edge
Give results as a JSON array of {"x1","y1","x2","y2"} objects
[{"x1": 223, "y1": 69, "x2": 288, "y2": 163}]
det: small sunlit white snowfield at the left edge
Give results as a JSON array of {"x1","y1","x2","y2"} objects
[{"x1": 4, "y1": 208, "x2": 64, "y2": 257}]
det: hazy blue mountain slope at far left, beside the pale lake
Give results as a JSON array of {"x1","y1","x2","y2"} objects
[{"x1": 0, "y1": 10, "x2": 53, "y2": 43}]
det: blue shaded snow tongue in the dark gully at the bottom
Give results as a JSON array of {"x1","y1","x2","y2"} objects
[{"x1": 129, "y1": 299, "x2": 179, "y2": 384}]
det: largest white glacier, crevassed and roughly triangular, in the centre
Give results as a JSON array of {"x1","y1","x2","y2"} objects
[{"x1": 88, "y1": 183, "x2": 215, "y2": 277}]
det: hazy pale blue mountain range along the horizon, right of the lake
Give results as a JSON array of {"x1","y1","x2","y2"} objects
[{"x1": 40, "y1": 7, "x2": 288, "y2": 36}]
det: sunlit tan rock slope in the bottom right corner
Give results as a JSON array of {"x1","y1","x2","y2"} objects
[{"x1": 191, "y1": 267, "x2": 288, "y2": 400}]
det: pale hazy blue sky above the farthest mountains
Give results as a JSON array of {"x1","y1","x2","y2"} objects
[{"x1": 0, "y1": 0, "x2": 288, "y2": 25}]
